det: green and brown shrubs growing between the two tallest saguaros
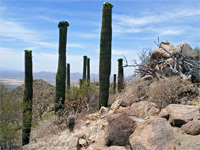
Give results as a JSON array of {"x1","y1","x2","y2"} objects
[{"x1": 55, "y1": 82, "x2": 98, "y2": 123}]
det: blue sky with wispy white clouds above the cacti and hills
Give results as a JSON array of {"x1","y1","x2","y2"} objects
[{"x1": 0, "y1": 0, "x2": 200, "y2": 75}]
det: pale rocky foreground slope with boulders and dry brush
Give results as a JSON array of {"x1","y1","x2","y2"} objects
[{"x1": 21, "y1": 78, "x2": 200, "y2": 150}]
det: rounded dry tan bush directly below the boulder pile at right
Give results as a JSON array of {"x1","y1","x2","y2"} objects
[{"x1": 148, "y1": 76, "x2": 199, "y2": 108}]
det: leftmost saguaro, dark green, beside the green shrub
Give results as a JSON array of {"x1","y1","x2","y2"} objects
[{"x1": 22, "y1": 50, "x2": 33, "y2": 145}]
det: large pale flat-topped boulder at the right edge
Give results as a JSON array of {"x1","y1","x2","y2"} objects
[{"x1": 158, "y1": 104, "x2": 200, "y2": 127}]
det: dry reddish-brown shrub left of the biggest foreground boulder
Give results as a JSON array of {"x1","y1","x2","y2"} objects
[{"x1": 106, "y1": 113, "x2": 135, "y2": 146}]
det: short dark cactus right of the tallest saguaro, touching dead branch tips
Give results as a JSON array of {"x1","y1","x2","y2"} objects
[{"x1": 118, "y1": 59, "x2": 124, "y2": 92}]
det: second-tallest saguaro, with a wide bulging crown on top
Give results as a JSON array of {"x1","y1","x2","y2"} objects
[{"x1": 55, "y1": 21, "x2": 69, "y2": 113}]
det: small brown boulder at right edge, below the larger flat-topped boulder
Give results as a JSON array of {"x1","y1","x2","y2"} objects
[{"x1": 181, "y1": 120, "x2": 200, "y2": 135}]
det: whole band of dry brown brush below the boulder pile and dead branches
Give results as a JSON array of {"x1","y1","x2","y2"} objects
[{"x1": 113, "y1": 76, "x2": 199, "y2": 108}]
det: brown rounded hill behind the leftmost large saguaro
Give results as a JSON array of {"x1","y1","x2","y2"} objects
[{"x1": 10, "y1": 80, "x2": 55, "y2": 120}]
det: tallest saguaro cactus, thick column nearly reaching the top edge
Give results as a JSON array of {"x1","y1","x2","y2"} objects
[{"x1": 99, "y1": 2, "x2": 113, "y2": 108}]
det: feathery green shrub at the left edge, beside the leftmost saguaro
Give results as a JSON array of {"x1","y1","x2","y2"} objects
[{"x1": 0, "y1": 82, "x2": 22, "y2": 149}]
